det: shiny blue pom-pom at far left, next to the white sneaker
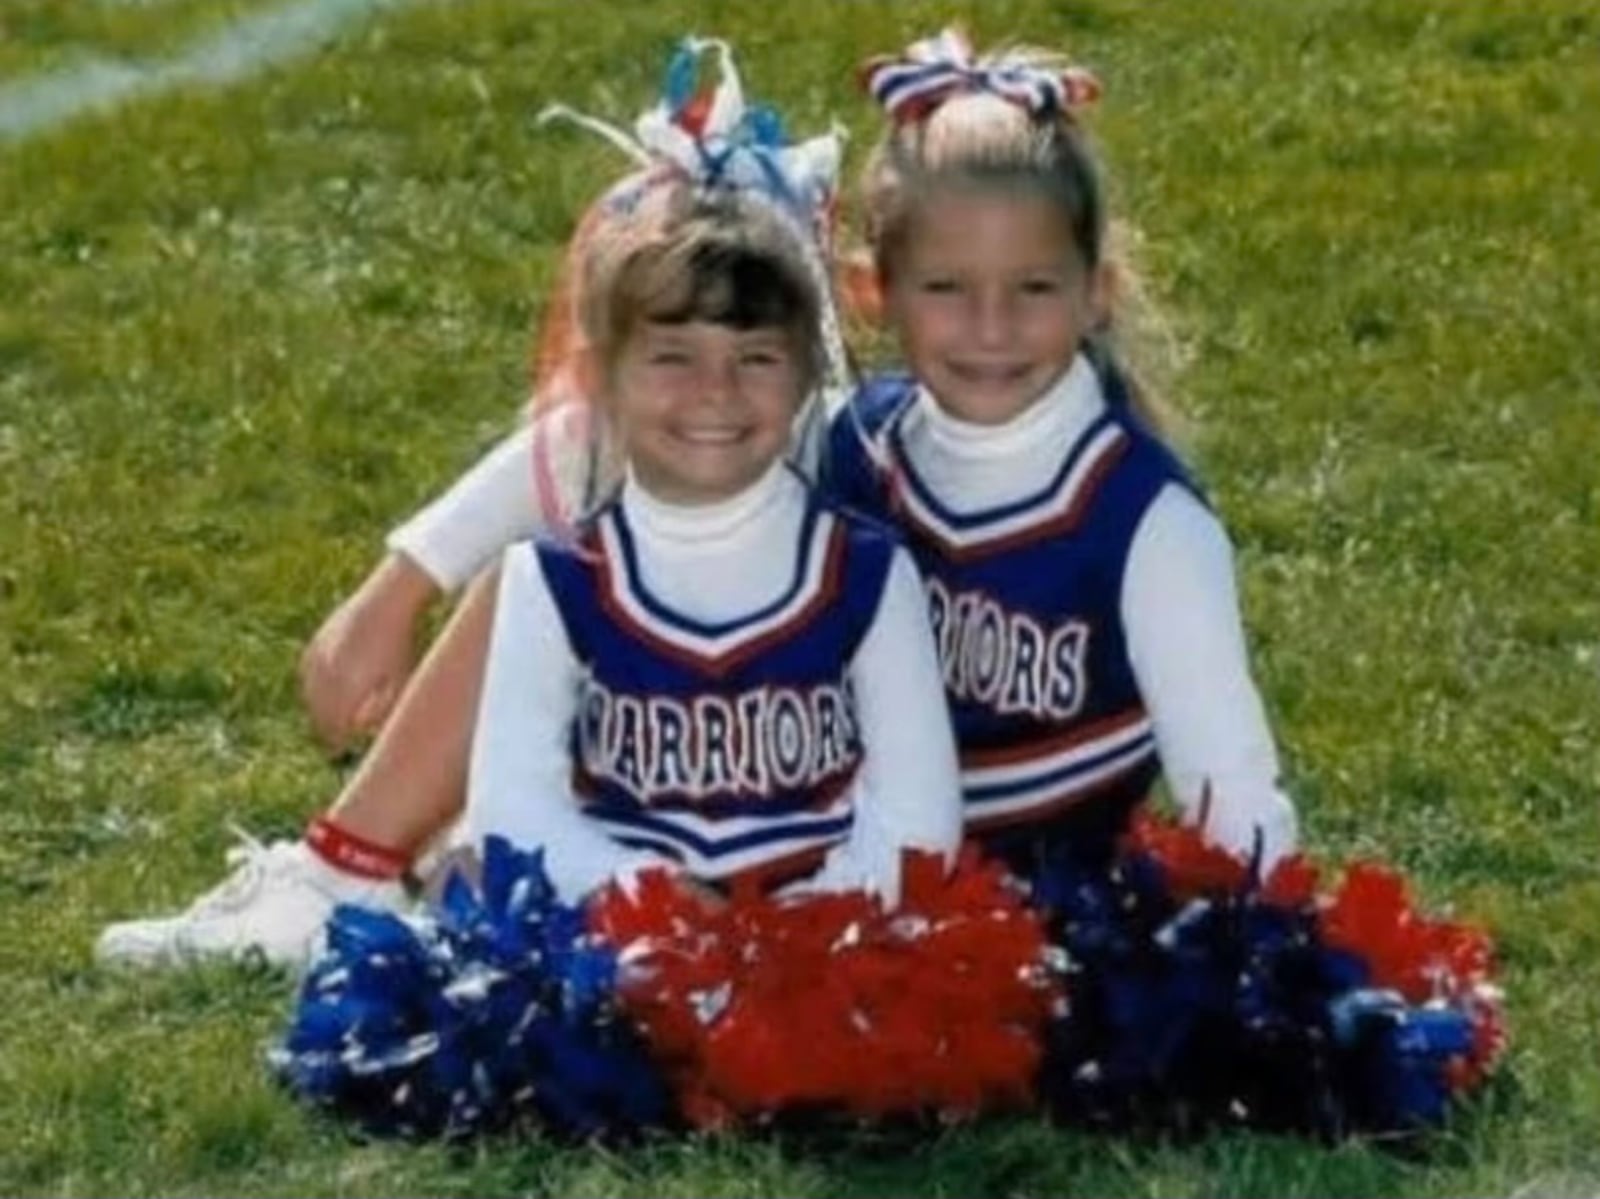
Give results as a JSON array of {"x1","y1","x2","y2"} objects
[{"x1": 269, "y1": 839, "x2": 672, "y2": 1137}]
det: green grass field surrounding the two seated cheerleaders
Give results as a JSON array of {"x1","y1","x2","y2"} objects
[{"x1": 0, "y1": 0, "x2": 1600, "y2": 1197}]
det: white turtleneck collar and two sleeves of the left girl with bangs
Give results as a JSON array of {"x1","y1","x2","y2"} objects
[{"x1": 467, "y1": 467, "x2": 962, "y2": 898}]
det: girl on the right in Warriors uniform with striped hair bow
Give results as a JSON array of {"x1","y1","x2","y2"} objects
[{"x1": 826, "y1": 32, "x2": 1296, "y2": 876}]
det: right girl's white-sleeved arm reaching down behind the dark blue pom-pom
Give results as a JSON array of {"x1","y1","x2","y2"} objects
[{"x1": 1122, "y1": 487, "x2": 1298, "y2": 866}]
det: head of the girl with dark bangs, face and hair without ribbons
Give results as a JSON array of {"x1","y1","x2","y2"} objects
[{"x1": 579, "y1": 187, "x2": 821, "y2": 504}]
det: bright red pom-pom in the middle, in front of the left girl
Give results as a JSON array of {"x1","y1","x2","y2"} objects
[{"x1": 592, "y1": 855, "x2": 1059, "y2": 1127}]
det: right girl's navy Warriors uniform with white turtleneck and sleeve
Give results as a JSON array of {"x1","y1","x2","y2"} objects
[{"x1": 826, "y1": 355, "x2": 1294, "y2": 874}]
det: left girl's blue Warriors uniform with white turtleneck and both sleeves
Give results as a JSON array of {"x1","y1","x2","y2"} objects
[{"x1": 467, "y1": 466, "x2": 960, "y2": 896}]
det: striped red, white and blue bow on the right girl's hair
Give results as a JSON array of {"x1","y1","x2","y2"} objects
[{"x1": 861, "y1": 29, "x2": 1101, "y2": 123}]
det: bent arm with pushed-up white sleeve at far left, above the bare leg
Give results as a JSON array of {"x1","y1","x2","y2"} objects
[{"x1": 299, "y1": 427, "x2": 544, "y2": 751}]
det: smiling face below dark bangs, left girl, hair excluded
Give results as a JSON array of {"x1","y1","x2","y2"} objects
[{"x1": 608, "y1": 320, "x2": 806, "y2": 504}]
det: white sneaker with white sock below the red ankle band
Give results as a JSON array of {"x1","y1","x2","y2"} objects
[{"x1": 94, "y1": 832, "x2": 406, "y2": 970}]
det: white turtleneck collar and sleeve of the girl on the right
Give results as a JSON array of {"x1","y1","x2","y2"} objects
[{"x1": 904, "y1": 357, "x2": 1298, "y2": 863}]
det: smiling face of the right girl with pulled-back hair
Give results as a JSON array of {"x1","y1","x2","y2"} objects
[{"x1": 886, "y1": 187, "x2": 1106, "y2": 424}]
